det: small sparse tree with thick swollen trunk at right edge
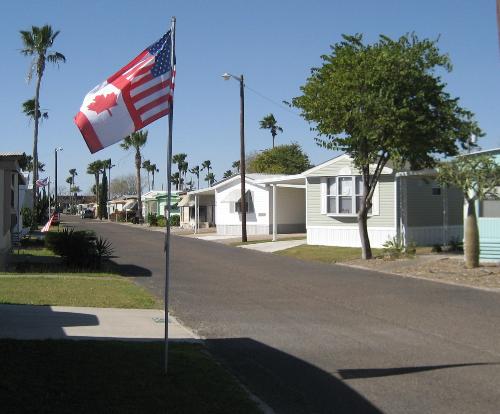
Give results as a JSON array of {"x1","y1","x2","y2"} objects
[{"x1": 438, "y1": 154, "x2": 500, "y2": 269}]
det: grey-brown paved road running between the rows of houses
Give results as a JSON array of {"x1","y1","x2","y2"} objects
[{"x1": 66, "y1": 218, "x2": 500, "y2": 413}]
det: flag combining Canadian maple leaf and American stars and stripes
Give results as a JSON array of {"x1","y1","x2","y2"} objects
[{"x1": 75, "y1": 30, "x2": 175, "y2": 153}]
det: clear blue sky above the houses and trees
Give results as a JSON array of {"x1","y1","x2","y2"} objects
[{"x1": 0, "y1": 0, "x2": 500, "y2": 191}]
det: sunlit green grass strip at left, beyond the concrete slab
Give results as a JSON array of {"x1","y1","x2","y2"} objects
[{"x1": 0, "y1": 274, "x2": 160, "y2": 309}]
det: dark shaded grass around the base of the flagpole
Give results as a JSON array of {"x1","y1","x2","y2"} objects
[{"x1": 0, "y1": 340, "x2": 259, "y2": 414}]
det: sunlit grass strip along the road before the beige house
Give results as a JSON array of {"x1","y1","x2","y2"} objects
[{"x1": 275, "y1": 244, "x2": 383, "y2": 263}]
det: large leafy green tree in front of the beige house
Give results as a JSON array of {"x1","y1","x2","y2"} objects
[{"x1": 292, "y1": 34, "x2": 482, "y2": 259}]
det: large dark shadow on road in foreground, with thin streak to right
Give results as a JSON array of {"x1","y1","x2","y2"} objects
[{"x1": 205, "y1": 338, "x2": 498, "y2": 414}]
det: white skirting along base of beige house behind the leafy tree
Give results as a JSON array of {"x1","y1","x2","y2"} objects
[{"x1": 307, "y1": 227, "x2": 396, "y2": 247}]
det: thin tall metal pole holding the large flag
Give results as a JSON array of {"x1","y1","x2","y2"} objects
[{"x1": 165, "y1": 17, "x2": 175, "y2": 375}]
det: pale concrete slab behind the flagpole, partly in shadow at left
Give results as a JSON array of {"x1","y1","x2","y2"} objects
[{"x1": 0, "y1": 305, "x2": 199, "y2": 341}]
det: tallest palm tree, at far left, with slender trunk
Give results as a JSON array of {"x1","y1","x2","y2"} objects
[{"x1": 19, "y1": 25, "x2": 66, "y2": 211}]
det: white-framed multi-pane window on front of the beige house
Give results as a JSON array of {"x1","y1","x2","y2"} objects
[{"x1": 326, "y1": 176, "x2": 371, "y2": 216}]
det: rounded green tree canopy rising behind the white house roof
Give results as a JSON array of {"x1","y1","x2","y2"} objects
[{"x1": 248, "y1": 143, "x2": 311, "y2": 174}]
